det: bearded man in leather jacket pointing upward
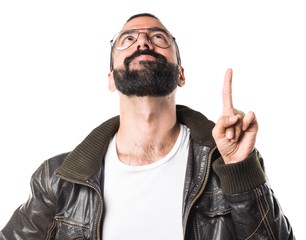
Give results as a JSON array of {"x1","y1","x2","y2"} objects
[{"x1": 0, "y1": 13, "x2": 294, "y2": 240}]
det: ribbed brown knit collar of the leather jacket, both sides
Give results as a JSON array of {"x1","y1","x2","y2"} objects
[{"x1": 57, "y1": 105, "x2": 215, "y2": 181}]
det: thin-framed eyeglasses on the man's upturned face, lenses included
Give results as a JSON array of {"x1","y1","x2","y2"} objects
[{"x1": 110, "y1": 27, "x2": 175, "y2": 51}]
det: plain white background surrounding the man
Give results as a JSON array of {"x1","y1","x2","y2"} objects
[{"x1": 0, "y1": 0, "x2": 306, "y2": 239}]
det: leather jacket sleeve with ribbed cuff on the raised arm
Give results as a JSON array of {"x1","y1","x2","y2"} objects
[{"x1": 213, "y1": 150, "x2": 295, "y2": 239}]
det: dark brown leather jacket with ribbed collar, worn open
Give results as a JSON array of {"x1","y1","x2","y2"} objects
[{"x1": 0, "y1": 105, "x2": 295, "y2": 240}]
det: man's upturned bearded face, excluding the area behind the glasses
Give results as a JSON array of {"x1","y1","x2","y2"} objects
[{"x1": 109, "y1": 17, "x2": 182, "y2": 96}]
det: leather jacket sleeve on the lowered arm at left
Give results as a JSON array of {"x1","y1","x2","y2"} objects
[{"x1": 0, "y1": 161, "x2": 55, "y2": 240}]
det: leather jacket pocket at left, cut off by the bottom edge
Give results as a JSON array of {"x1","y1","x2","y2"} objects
[{"x1": 54, "y1": 217, "x2": 90, "y2": 240}]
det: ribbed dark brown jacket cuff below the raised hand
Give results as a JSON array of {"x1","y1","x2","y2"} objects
[{"x1": 213, "y1": 150, "x2": 266, "y2": 194}]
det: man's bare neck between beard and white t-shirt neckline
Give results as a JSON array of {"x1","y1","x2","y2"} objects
[{"x1": 116, "y1": 96, "x2": 180, "y2": 165}]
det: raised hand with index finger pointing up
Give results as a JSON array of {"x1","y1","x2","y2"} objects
[{"x1": 212, "y1": 69, "x2": 258, "y2": 164}]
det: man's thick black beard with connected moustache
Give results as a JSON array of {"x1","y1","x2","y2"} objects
[{"x1": 114, "y1": 50, "x2": 179, "y2": 97}]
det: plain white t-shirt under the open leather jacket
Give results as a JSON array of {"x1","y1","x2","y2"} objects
[{"x1": 103, "y1": 125, "x2": 190, "y2": 240}]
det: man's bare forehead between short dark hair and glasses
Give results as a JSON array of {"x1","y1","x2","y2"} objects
[{"x1": 121, "y1": 17, "x2": 166, "y2": 31}]
